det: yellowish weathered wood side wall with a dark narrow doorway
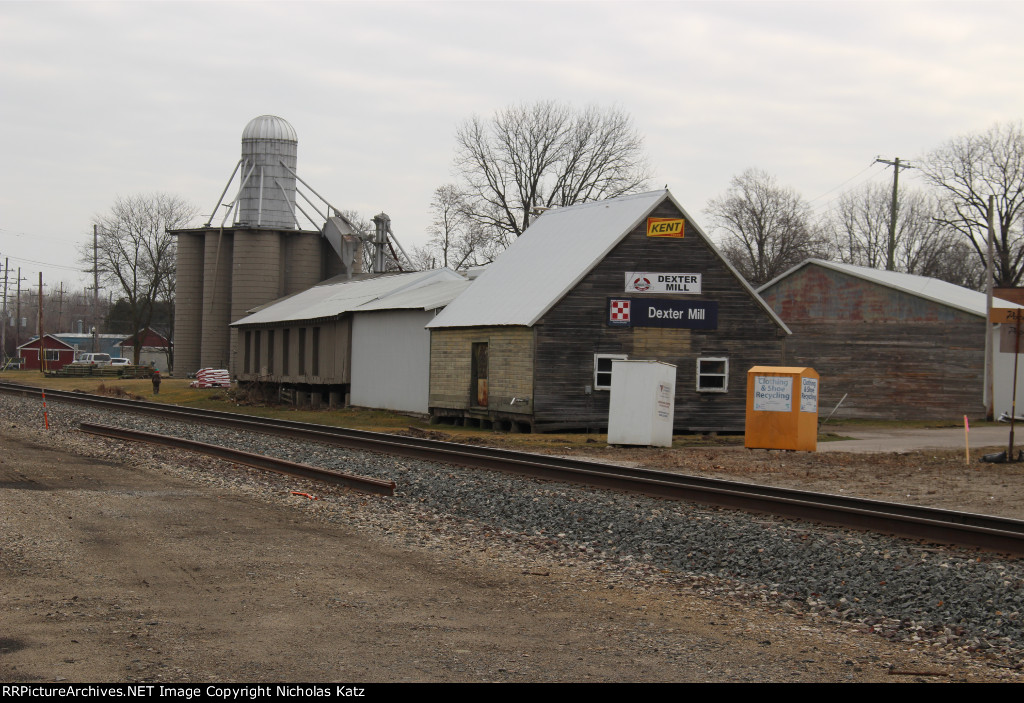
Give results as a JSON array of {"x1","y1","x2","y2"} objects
[{"x1": 429, "y1": 326, "x2": 534, "y2": 415}]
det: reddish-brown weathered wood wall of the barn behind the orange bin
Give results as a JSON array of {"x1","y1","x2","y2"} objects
[{"x1": 763, "y1": 265, "x2": 985, "y2": 420}]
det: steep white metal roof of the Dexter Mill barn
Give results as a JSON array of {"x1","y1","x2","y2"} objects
[{"x1": 427, "y1": 189, "x2": 788, "y2": 332}]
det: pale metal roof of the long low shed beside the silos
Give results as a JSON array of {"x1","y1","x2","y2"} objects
[{"x1": 231, "y1": 268, "x2": 465, "y2": 326}]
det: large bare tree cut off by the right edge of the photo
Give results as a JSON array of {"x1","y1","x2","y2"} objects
[{"x1": 921, "y1": 122, "x2": 1024, "y2": 287}]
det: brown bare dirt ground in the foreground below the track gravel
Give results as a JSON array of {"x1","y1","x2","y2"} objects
[{"x1": 0, "y1": 429, "x2": 1016, "y2": 682}]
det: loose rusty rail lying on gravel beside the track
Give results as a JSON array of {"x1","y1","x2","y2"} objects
[{"x1": 78, "y1": 423, "x2": 395, "y2": 495}]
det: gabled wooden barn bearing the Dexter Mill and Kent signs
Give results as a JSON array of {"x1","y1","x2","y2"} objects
[{"x1": 427, "y1": 190, "x2": 788, "y2": 431}]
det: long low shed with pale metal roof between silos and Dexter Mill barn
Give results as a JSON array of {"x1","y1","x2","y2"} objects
[{"x1": 231, "y1": 268, "x2": 469, "y2": 412}]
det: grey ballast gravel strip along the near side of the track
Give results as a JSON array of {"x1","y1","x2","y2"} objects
[{"x1": 0, "y1": 395, "x2": 1024, "y2": 671}]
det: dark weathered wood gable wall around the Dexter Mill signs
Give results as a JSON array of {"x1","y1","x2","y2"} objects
[{"x1": 535, "y1": 203, "x2": 785, "y2": 430}]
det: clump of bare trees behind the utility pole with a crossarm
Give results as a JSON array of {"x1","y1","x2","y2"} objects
[{"x1": 824, "y1": 183, "x2": 979, "y2": 288}]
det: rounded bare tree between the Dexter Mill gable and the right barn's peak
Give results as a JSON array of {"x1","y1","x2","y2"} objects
[{"x1": 705, "y1": 169, "x2": 827, "y2": 284}]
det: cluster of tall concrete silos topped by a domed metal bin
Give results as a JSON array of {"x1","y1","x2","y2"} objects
[{"x1": 173, "y1": 115, "x2": 360, "y2": 377}]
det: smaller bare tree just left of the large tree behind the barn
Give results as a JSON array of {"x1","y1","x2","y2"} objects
[{"x1": 414, "y1": 184, "x2": 509, "y2": 270}]
